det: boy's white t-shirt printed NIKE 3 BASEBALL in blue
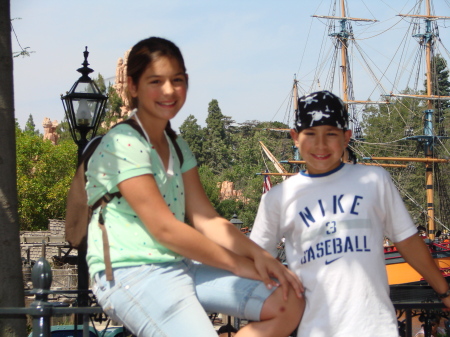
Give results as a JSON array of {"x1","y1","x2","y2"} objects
[{"x1": 250, "y1": 164, "x2": 417, "y2": 337}]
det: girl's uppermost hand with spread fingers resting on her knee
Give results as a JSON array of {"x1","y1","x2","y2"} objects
[{"x1": 254, "y1": 251, "x2": 305, "y2": 300}]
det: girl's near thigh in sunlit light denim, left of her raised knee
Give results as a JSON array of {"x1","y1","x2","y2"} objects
[{"x1": 93, "y1": 262, "x2": 217, "y2": 337}]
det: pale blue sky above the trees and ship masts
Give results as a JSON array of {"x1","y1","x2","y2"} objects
[{"x1": 11, "y1": 0, "x2": 450, "y2": 132}]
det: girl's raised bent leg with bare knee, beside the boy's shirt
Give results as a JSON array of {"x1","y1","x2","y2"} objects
[{"x1": 193, "y1": 264, "x2": 305, "y2": 337}]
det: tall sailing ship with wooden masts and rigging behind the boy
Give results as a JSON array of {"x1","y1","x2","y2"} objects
[{"x1": 261, "y1": 0, "x2": 450, "y2": 285}]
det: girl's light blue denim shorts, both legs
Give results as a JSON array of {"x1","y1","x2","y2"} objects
[{"x1": 93, "y1": 259, "x2": 274, "y2": 337}]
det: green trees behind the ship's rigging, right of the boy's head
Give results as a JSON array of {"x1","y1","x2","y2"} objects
[{"x1": 355, "y1": 89, "x2": 450, "y2": 225}]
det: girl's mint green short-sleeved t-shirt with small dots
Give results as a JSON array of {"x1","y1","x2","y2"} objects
[{"x1": 86, "y1": 124, "x2": 197, "y2": 275}]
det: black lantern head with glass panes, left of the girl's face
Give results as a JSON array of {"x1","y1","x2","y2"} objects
[{"x1": 61, "y1": 47, "x2": 108, "y2": 160}]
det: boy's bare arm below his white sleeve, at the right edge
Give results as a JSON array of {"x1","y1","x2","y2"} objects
[{"x1": 395, "y1": 234, "x2": 450, "y2": 308}]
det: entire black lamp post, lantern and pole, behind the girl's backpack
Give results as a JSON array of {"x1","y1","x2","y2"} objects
[{"x1": 61, "y1": 47, "x2": 108, "y2": 324}]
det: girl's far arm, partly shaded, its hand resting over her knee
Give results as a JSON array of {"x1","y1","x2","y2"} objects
[{"x1": 183, "y1": 168, "x2": 304, "y2": 298}]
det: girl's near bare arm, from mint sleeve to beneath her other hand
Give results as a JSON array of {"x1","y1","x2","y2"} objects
[{"x1": 118, "y1": 174, "x2": 261, "y2": 280}]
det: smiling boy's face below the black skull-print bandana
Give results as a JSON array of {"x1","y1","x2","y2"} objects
[{"x1": 291, "y1": 125, "x2": 352, "y2": 174}]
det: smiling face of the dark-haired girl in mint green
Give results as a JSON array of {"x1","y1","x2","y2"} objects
[{"x1": 128, "y1": 56, "x2": 187, "y2": 121}]
